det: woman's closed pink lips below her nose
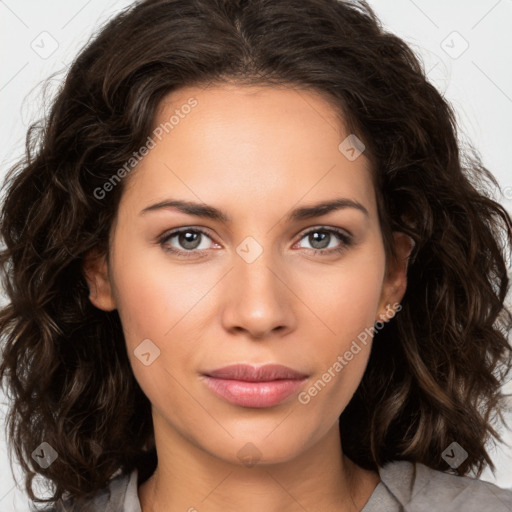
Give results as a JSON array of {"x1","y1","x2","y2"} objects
[{"x1": 203, "y1": 364, "x2": 308, "y2": 408}]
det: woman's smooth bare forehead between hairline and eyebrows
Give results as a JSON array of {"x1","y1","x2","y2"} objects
[{"x1": 119, "y1": 85, "x2": 374, "y2": 221}]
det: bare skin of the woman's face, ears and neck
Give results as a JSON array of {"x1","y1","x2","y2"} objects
[{"x1": 84, "y1": 84, "x2": 411, "y2": 512}]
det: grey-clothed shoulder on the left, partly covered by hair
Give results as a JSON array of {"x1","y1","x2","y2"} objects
[{"x1": 31, "y1": 469, "x2": 141, "y2": 512}]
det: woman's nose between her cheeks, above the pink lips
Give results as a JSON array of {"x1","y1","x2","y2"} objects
[{"x1": 222, "y1": 251, "x2": 298, "y2": 339}]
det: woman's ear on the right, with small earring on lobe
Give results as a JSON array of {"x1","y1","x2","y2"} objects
[{"x1": 376, "y1": 231, "x2": 414, "y2": 321}]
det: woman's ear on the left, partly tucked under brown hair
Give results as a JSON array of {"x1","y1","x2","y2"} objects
[{"x1": 82, "y1": 249, "x2": 116, "y2": 311}]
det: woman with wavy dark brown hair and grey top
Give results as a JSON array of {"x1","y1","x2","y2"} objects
[{"x1": 0, "y1": 0, "x2": 512, "y2": 512}]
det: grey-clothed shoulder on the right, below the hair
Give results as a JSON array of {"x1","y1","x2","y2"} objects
[{"x1": 379, "y1": 461, "x2": 512, "y2": 512}]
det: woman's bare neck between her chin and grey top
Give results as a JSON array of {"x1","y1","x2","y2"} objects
[{"x1": 138, "y1": 412, "x2": 380, "y2": 512}]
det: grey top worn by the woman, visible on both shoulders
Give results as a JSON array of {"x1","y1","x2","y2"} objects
[{"x1": 39, "y1": 461, "x2": 512, "y2": 512}]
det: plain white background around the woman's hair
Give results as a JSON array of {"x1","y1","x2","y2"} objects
[{"x1": 0, "y1": 0, "x2": 512, "y2": 506}]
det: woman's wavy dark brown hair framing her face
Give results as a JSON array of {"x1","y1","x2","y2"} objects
[{"x1": 0, "y1": 0, "x2": 512, "y2": 502}]
